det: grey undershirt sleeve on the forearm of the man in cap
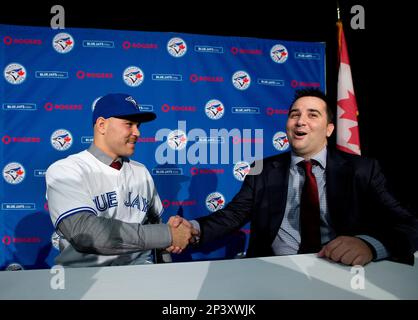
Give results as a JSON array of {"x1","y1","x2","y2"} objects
[{"x1": 58, "y1": 212, "x2": 172, "y2": 255}]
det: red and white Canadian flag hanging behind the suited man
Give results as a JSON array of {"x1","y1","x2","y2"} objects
[{"x1": 337, "y1": 20, "x2": 361, "y2": 155}]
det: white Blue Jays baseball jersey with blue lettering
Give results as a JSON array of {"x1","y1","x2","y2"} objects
[{"x1": 45, "y1": 150, "x2": 163, "y2": 265}]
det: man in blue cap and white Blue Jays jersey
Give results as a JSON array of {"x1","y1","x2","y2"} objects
[{"x1": 46, "y1": 93, "x2": 195, "y2": 267}]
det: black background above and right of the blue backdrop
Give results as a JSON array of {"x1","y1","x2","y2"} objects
[{"x1": 0, "y1": 0, "x2": 418, "y2": 212}]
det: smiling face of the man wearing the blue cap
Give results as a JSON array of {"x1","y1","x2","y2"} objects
[{"x1": 94, "y1": 117, "x2": 140, "y2": 159}]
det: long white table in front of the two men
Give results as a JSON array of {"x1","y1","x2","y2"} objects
[{"x1": 0, "y1": 253, "x2": 418, "y2": 300}]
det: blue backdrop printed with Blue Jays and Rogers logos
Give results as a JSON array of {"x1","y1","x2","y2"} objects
[{"x1": 0, "y1": 25, "x2": 325, "y2": 270}]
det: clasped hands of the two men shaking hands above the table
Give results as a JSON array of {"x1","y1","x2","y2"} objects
[{"x1": 166, "y1": 216, "x2": 200, "y2": 253}]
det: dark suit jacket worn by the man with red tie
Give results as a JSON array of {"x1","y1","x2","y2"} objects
[{"x1": 196, "y1": 148, "x2": 418, "y2": 264}]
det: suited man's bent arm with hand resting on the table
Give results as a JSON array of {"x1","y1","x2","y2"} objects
[{"x1": 318, "y1": 158, "x2": 418, "y2": 265}]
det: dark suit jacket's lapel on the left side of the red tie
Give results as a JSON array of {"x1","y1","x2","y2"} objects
[{"x1": 266, "y1": 152, "x2": 290, "y2": 241}]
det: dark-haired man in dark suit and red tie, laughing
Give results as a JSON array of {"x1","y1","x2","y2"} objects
[{"x1": 171, "y1": 89, "x2": 418, "y2": 265}]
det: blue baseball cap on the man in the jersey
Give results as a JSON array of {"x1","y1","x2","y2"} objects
[{"x1": 93, "y1": 93, "x2": 157, "y2": 126}]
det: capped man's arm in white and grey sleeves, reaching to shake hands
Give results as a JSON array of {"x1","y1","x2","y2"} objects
[{"x1": 46, "y1": 161, "x2": 191, "y2": 255}]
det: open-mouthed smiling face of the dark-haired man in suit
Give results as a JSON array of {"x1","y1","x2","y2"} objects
[{"x1": 286, "y1": 96, "x2": 334, "y2": 159}]
